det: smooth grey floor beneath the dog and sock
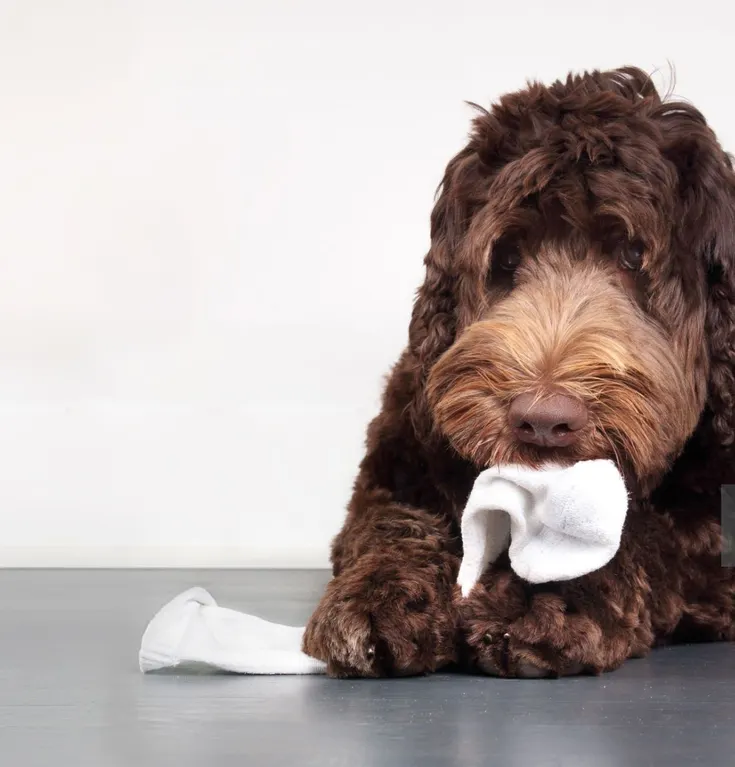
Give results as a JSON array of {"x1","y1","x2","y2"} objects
[{"x1": 0, "y1": 570, "x2": 735, "y2": 767}]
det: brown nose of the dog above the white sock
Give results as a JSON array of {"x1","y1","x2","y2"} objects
[{"x1": 508, "y1": 392, "x2": 587, "y2": 447}]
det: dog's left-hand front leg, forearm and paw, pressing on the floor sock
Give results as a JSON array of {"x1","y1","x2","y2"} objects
[{"x1": 303, "y1": 491, "x2": 458, "y2": 677}]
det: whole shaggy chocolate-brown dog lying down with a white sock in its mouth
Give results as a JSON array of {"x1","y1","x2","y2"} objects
[{"x1": 303, "y1": 67, "x2": 735, "y2": 677}]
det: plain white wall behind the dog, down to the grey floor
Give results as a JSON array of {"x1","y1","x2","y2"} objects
[{"x1": 0, "y1": 0, "x2": 735, "y2": 566}]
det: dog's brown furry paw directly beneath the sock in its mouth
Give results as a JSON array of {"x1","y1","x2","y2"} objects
[{"x1": 459, "y1": 573, "x2": 645, "y2": 679}]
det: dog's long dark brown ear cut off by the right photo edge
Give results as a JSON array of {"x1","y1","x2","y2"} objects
[{"x1": 661, "y1": 103, "x2": 735, "y2": 453}]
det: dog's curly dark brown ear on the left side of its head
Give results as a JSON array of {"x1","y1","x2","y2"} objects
[{"x1": 409, "y1": 146, "x2": 481, "y2": 374}]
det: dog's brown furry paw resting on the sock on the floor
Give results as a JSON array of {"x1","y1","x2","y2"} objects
[{"x1": 303, "y1": 557, "x2": 456, "y2": 677}]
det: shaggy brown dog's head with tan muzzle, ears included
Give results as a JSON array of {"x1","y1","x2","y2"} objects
[{"x1": 410, "y1": 69, "x2": 735, "y2": 486}]
